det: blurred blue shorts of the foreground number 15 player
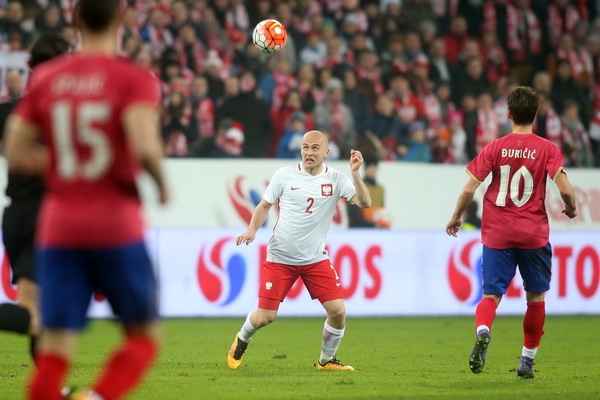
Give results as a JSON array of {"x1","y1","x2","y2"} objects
[{"x1": 36, "y1": 242, "x2": 158, "y2": 330}]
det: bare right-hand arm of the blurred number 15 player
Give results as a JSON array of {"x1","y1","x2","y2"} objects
[{"x1": 123, "y1": 103, "x2": 169, "y2": 204}]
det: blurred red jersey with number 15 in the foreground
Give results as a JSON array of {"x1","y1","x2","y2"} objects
[{"x1": 16, "y1": 54, "x2": 160, "y2": 248}]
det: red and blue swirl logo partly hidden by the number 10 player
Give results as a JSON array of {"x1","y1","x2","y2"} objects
[{"x1": 448, "y1": 239, "x2": 482, "y2": 304}]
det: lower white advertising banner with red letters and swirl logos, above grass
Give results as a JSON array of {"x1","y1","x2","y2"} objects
[{"x1": 0, "y1": 228, "x2": 600, "y2": 317}]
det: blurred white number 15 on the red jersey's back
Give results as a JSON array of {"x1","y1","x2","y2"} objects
[{"x1": 50, "y1": 101, "x2": 113, "y2": 181}]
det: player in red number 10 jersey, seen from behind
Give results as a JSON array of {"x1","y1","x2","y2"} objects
[{"x1": 446, "y1": 87, "x2": 577, "y2": 378}]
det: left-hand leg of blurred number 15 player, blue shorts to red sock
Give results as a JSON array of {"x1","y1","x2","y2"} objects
[{"x1": 28, "y1": 249, "x2": 93, "y2": 400}]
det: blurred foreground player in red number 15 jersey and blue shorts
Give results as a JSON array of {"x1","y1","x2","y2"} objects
[{"x1": 6, "y1": 0, "x2": 168, "y2": 400}]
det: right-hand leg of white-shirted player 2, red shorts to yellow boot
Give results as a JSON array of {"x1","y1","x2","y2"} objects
[{"x1": 302, "y1": 260, "x2": 354, "y2": 371}]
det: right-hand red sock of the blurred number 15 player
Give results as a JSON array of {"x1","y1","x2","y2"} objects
[{"x1": 94, "y1": 337, "x2": 157, "y2": 400}]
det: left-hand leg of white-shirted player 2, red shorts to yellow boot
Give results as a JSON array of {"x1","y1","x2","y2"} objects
[{"x1": 227, "y1": 261, "x2": 300, "y2": 369}]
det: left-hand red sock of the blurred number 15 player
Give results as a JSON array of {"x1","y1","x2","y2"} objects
[{"x1": 27, "y1": 354, "x2": 69, "y2": 400}]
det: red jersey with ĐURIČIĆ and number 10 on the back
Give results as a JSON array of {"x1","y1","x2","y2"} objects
[{"x1": 466, "y1": 133, "x2": 563, "y2": 249}]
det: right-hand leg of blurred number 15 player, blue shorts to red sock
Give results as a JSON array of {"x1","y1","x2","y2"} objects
[{"x1": 84, "y1": 243, "x2": 160, "y2": 400}]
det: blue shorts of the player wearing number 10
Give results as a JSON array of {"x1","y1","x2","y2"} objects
[{"x1": 481, "y1": 243, "x2": 552, "y2": 295}]
